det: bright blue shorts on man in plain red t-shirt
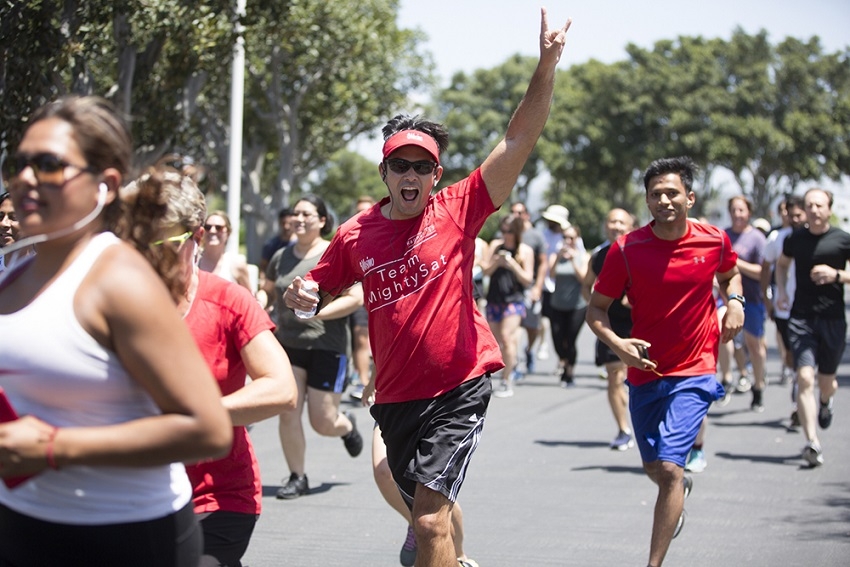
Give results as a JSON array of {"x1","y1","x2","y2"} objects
[{"x1": 629, "y1": 374, "x2": 723, "y2": 467}]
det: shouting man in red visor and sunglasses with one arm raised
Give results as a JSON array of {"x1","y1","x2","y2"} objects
[{"x1": 284, "y1": 9, "x2": 570, "y2": 566}]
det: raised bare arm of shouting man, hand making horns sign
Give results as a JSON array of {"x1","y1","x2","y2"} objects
[{"x1": 481, "y1": 8, "x2": 572, "y2": 208}]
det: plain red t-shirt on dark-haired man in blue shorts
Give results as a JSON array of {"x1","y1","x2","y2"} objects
[{"x1": 594, "y1": 221, "x2": 738, "y2": 386}]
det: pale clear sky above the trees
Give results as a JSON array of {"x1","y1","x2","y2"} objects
[{"x1": 399, "y1": 0, "x2": 850, "y2": 81}]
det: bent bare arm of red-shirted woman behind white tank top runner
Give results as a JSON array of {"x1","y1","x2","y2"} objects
[{"x1": 221, "y1": 331, "x2": 296, "y2": 425}]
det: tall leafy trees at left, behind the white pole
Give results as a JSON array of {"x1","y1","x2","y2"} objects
[{"x1": 0, "y1": 0, "x2": 433, "y2": 259}]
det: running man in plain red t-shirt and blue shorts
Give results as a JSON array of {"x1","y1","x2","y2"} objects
[{"x1": 587, "y1": 157, "x2": 744, "y2": 567}]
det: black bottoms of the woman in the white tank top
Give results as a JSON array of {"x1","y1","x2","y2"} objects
[{"x1": 0, "y1": 502, "x2": 203, "y2": 567}]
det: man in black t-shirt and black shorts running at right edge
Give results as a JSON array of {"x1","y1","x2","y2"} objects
[{"x1": 775, "y1": 188, "x2": 850, "y2": 467}]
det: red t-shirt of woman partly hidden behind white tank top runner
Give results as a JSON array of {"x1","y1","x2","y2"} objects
[{"x1": 185, "y1": 270, "x2": 274, "y2": 514}]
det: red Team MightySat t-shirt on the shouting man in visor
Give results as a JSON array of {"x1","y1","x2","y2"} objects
[{"x1": 309, "y1": 170, "x2": 504, "y2": 403}]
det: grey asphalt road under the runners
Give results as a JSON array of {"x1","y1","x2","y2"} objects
[{"x1": 238, "y1": 324, "x2": 850, "y2": 567}]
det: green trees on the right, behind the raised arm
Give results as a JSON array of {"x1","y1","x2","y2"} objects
[{"x1": 435, "y1": 30, "x2": 850, "y2": 242}]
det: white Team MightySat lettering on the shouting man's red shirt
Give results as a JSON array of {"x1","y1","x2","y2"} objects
[{"x1": 364, "y1": 254, "x2": 448, "y2": 311}]
